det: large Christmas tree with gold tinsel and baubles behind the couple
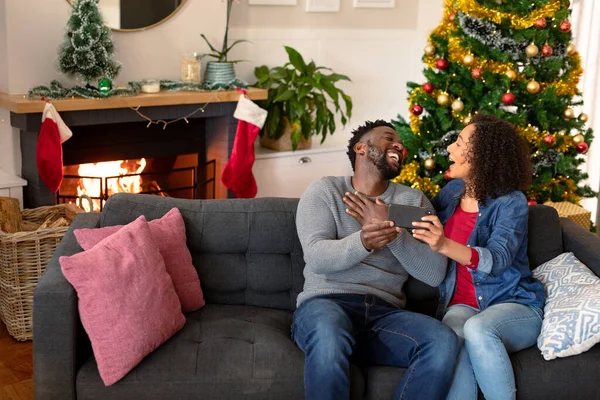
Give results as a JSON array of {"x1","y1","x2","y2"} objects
[{"x1": 394, "y1": 0, "x2": 595, "y2": 204}]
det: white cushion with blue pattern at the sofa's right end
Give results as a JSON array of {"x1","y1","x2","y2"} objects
[{"x1": 533, "y1": 253, "x2": 600, "y2": 360}]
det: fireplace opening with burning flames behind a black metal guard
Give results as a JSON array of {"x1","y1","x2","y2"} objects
[{"x1": 57, "y1": 154, "x2": 216, "y2": 211}]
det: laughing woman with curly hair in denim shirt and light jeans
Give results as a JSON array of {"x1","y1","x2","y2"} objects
[{"x1": 413, "y1": 114, "x2": 544, "y2": 400}]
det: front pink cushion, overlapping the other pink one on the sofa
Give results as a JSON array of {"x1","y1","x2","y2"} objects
[{"x1": 59, "y1": 216, "x2": 185, "y2": 386}]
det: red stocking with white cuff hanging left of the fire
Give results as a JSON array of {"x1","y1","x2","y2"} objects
[{"x1": 36, "y1": 103, "x2": 72, "y2": 193}]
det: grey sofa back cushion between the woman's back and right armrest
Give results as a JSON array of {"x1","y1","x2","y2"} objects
[{"x1": 527, "y1": 205, "x2": 563, "y2": 269}]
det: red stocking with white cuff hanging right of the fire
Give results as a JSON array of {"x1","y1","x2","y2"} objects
[{"x1": 221, "y1": 94, "x2": 267, "y2": 198}]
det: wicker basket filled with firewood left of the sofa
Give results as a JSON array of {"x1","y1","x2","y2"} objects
[{"x1": 0, "y1": 204, "x2": 73, "y2": 340}]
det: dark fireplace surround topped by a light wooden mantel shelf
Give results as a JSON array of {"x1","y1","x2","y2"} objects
[{"x1": 0, "y1": 89, "x2": 267, "y2": 208}]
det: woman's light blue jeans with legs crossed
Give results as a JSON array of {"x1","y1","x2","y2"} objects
[{"x1": 442, "y1": 303, "x2": 542, "y2": 400}]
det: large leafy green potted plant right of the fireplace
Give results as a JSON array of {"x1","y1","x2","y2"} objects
[{"x1": 254, "y1": 46, "x2": 352, "y2": 150}]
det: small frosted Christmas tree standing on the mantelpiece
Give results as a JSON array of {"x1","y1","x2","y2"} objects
[{"x1": 58, "y1": 0, "x2": 121, "y2": 83}]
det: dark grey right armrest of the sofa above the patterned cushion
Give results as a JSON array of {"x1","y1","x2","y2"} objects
[{"x1": 560, "y1": 218, "x2": 600, "y2": 276}]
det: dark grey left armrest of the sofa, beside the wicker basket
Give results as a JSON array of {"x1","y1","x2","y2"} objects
[{"x1": 33, "y1": 213, "x2": 100, "y2": 400}]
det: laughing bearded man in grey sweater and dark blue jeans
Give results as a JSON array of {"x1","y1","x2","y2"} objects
[{"x1": 292, "y1": 120, "x2": 458, "y2": 400}]
